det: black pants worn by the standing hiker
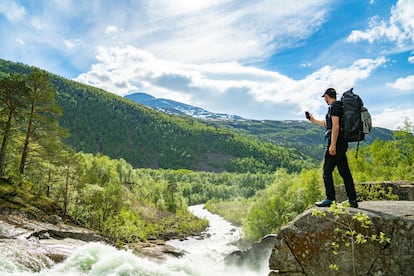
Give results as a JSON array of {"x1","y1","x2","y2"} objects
[{"x1": 323, "y1": 137, "x2": 356, "y2": 200}]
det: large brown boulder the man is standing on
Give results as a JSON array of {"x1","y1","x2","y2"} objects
[{"x1": 269, "y1": 201, "x2": 414, "y2": 275}]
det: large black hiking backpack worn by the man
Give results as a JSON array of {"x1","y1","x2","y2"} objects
[{"x1": 341, "y1": 88, "x2": 372, "y2": 154}]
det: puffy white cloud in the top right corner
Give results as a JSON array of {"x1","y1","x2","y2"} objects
[{"x1": 347, "y1": 0, "x2": 414, "y2": 47}]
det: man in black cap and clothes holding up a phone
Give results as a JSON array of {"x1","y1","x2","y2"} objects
[{"x1": 308, "y1": 88, "x2": 358, "y2": 208}]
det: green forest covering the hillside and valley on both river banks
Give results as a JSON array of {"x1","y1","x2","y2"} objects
[{"x1": 0, "y1": 60, "x2": 414, "y2": 246}]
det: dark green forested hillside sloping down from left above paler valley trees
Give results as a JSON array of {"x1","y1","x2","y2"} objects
[{"x1": 0, "y1": 60, "x2": 312, "y2": 172}]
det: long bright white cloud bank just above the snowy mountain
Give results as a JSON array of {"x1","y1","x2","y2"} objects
[{"x1": 76, "y1": 46, "x2": 386, "y2": 119}]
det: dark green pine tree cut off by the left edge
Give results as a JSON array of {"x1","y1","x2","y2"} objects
[{"x1": 0, "y1": 74, "x2": 28, "y2": 177}]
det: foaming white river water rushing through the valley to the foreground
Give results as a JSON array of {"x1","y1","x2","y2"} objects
[{"x1": 0, "y1": 205, "x2": 270, "y2": 276}]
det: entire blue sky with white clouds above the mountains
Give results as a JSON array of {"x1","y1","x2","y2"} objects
[{"x1": 0, "y1": 0, "x2": 414, "y2": 129}]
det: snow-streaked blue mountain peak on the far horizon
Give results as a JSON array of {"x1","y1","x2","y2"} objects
[{"x1": 125, "y1": 92, "x2": 243, "y2": 120}]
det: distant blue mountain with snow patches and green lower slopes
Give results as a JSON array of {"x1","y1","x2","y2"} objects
[{"x1": 125, "y1": 92, "x2": 393, "y2": 160}]
